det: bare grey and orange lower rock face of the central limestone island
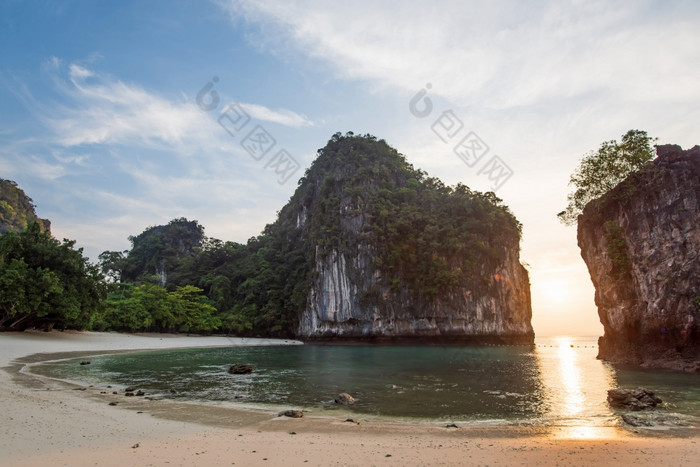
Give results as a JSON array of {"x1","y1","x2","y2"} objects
[{"x1": 299, "y1": 244, "x2": 534, "y2": 343}]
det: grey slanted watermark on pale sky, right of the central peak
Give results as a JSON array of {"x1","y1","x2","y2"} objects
[{"x1": 408, "y1": 83, "x2": 513, "y2": 192}]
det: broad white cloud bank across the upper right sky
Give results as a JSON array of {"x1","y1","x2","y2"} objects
[{"x1": 222, "y1": 0, "x2": 700, "y2": 107}]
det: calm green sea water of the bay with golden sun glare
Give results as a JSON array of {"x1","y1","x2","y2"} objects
[{"x1": 33, "y1": 337, "x2": 700, "y2": 432}]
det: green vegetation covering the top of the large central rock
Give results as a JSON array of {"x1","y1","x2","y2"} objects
[{"x1": 294, "y1": 133, "x2": 520, "y2": 303}]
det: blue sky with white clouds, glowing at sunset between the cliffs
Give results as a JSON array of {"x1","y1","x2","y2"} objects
[{"x1": 0, "y1": 0, "x2": 700, "y2": 335}]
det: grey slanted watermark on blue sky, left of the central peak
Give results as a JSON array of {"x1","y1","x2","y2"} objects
[{"x1": 196, "y1": 76, "x2": 301, "y2": 185}]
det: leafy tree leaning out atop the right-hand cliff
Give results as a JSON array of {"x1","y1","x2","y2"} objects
[{"x1": 557, "y1": 130, "x2": 656, "y2": 225}]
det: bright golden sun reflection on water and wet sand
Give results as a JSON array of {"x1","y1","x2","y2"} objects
[{"x1": 535, "y1": 337, "x2": 616, "y2": 439}]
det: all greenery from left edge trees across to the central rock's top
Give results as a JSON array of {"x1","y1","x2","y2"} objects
[{"x1": 0, "y1": 133, "x2": 520, "y2": 336}]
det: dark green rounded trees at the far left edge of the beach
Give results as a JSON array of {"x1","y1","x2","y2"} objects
[{"x1": 0, "y1": 222, "x2": 106, "y2": 330}]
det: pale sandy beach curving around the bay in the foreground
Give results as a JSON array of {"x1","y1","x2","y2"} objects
[{"x1": 0, "y1": 332, "x2": 700, "y2": 466}]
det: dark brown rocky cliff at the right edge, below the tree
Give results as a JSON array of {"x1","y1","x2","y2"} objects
[{"x1": 578, "y1": 145, "x2": 700, "y2": 371}]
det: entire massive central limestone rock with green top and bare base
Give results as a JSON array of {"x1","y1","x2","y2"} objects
[{"x1": 288, "y1": 133, "x2": 534, "y2": 343}]
